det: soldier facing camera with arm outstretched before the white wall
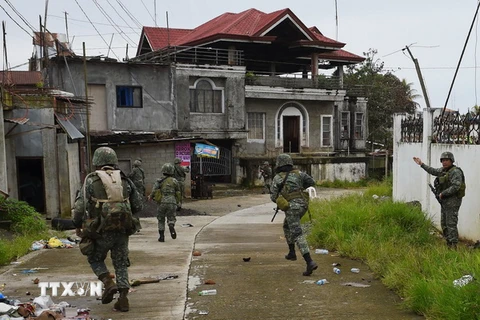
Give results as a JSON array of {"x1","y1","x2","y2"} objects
[{"x1": 413, "y1": 151, "x2": 466, "y2": 249}]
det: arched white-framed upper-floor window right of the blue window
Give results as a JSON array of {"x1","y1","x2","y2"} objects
[{"x1": 190, "y1": 79, "x2": 223, "y2": 113}]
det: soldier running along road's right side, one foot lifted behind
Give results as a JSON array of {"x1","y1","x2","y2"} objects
[{"x1": 270, "y1": 154, "x2": 318, "y2": 276}]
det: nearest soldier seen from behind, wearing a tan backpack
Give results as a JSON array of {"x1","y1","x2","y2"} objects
[{"x1": 73, "y1": 147, "x2": 143, "y2": 312}]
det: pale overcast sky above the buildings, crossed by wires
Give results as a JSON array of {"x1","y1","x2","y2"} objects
[{"x1": 0, "y1": 0, "x2": 480, "y2": 112}]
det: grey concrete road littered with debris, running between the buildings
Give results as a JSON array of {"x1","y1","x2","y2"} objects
[{"x1": 0, "y1": 190, "x2": 421, "y2": 320}]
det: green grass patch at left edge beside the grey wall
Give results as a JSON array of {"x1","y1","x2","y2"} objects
[{"x1": 0, "y1": 197, "x2": 52, "y2": 265}]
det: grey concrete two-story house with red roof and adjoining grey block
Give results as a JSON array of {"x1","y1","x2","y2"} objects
[{"x1": 48, "y1": 9, "x2": 368, "y2": 195}]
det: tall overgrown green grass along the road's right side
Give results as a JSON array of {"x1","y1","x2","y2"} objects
[{"x1": 308, "y1": 181, "x2": 480, "y2": 320}]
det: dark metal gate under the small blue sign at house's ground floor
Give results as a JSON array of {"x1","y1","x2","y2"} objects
[{"x1": 190, "y1": 147, "x2": 232, "y2": 177}]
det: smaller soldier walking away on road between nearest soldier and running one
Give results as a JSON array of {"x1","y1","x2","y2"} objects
[{"x1": 148, "y1": 163, "x2": 181, "y2": 242}]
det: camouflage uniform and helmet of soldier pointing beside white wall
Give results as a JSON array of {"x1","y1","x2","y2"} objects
[{"x1": 421, "y1": 153, "x2": 465, "y2": 247}]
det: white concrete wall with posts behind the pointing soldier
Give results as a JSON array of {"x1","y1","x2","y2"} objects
[{"x1": 393, "y1": 111, "x2": 480, "y2": 241}]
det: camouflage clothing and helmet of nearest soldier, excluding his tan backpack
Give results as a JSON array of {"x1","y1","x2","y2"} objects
[{"x1": 73, "y1": 147, "x2": 143, "y2": 312}]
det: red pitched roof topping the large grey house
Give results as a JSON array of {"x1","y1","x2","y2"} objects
[{"x1": 139, "y1": 9, "x2": 345, "y2": 51}]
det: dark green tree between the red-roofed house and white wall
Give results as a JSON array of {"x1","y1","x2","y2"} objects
[{"x1": 344, "y1": 49, "x2": 421, "y2": 147}]
